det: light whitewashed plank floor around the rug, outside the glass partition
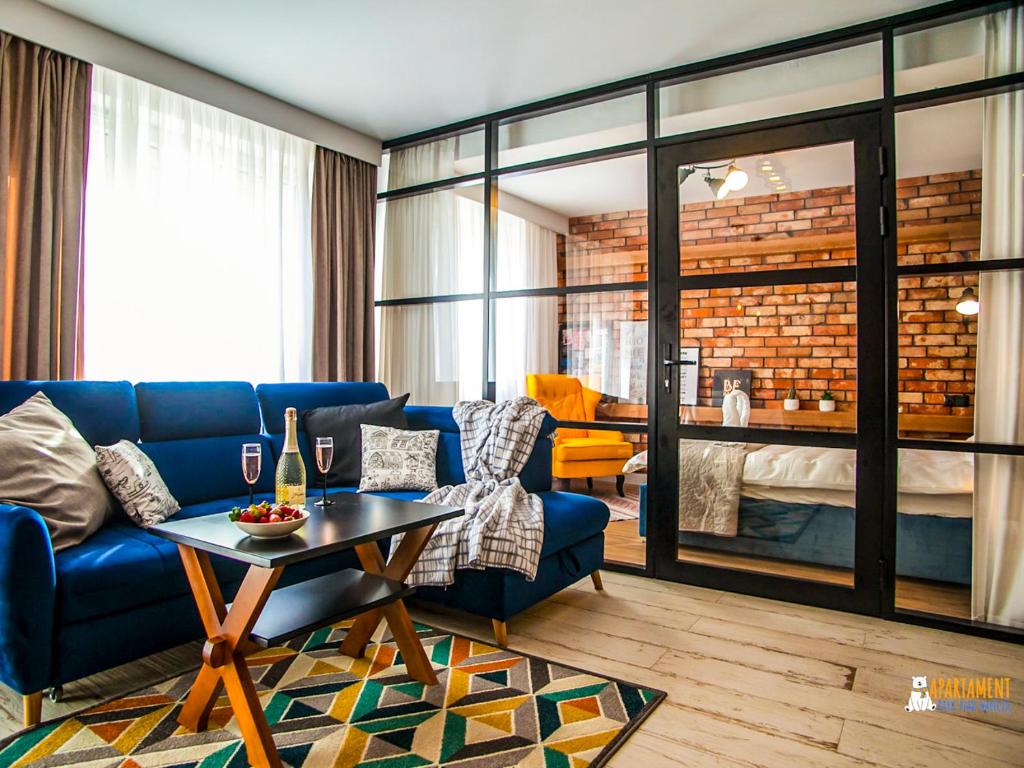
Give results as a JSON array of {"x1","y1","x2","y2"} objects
[{"x1": 0, "y1": 572, "x2": 1024, "y2": 768}]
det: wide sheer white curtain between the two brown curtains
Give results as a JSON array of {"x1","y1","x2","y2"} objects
[{"x1": 85, "y1": 67, "x2": 314, "y2": 382}]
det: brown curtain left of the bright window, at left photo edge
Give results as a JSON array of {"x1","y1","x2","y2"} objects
[{"x1": 0, "y1": 32, "x2": 92, "y2": 379}]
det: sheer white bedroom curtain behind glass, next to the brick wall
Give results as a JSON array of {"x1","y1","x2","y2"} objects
[{"x1": 495, "y1": 211, "x2": 558, "y2": 401}]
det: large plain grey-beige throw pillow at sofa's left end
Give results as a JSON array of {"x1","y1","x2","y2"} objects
[{"x1": 0, "y1": 392, "x2": 114, "y2": 551}]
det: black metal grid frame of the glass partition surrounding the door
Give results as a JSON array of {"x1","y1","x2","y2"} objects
[{"x1": 377, "y1": 0, "x2": 1024, "y2": 642}]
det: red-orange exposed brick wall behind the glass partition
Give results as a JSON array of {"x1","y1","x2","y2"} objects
[{"x1": 559, "y1": 171, "x2": 981, "y2": 415}]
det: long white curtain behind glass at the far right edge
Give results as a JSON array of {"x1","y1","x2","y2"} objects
[{"x1": 972, "y1": 8, "x2": 1024, "y2": 628}]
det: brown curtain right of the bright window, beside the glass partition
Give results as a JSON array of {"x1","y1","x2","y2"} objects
[{"x1": 312, "y1": 146, "x2": 377, "y2": 381}]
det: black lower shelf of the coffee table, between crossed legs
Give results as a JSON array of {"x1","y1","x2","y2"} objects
[{"x1": 250, "y1": 568, "x2": 416, "y2": 648}]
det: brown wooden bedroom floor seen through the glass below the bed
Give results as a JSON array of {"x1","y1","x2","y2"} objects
[{"x1": 604, "y1": 520, "x2": 971, "y2": 618}]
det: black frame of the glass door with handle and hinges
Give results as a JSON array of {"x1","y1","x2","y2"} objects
[{"x1": 647, "y1": 111, "x2": 885, "y2": 615}]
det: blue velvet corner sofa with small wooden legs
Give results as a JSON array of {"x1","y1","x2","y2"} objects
[{"x1": 0, "y1": 381, "x2": 608, "y2": 723}]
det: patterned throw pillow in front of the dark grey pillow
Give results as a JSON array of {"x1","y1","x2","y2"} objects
[{"x1": 359, "y1": 424, "x2": 440, "y2": 490}]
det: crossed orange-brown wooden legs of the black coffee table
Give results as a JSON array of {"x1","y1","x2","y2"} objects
[{"x1": 178, "y1": 524, "x2": 437, "y2": 768}]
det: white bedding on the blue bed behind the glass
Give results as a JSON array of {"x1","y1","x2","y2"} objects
[{"x1": 627, "y1": 444, "x2": 974, "y2": 517}]
